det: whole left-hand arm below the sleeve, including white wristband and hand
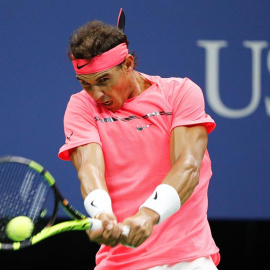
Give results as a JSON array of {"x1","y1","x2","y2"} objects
[{"x1": 71, "y1": 143, "x2": 122, "y2": 247}]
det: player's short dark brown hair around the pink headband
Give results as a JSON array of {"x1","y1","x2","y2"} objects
[{"x1": 68, "y1": 20, "x2": 137, "y2": 66}]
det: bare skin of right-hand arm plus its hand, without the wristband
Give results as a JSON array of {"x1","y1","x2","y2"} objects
[{"x1": 121, "y1": 125, "x2": 208, "y2": 247}]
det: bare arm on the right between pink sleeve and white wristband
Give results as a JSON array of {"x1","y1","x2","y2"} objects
[{"x1": 163, "y1": 126, "x2": 208, "y2": 205}]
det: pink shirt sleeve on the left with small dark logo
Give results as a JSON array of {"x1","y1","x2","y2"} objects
[{"x1": 58, "y1": 94, "x2": 101, "y2": 160}]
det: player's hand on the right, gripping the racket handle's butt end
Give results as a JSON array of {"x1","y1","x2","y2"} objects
[{"x1": 120, "y1": 207, "x2": 159, "y2": 247}]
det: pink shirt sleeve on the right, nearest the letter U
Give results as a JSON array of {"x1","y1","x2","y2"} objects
[{"x1": 170, "y1": 78, "x2": 216, "y2": 134}]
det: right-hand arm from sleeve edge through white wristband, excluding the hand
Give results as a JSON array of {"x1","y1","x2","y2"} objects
[{"x1": 138, "y1": 126, "x2": 207, "y2": 226}]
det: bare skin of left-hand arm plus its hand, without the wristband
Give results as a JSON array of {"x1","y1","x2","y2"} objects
[{"x1": 70, "y1": 143, "x2": 122, "y2": 246}]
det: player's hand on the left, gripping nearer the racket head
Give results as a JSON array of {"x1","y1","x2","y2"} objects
[{"x1": 86, "y1": 213, "x2": 122, "y2": 247}]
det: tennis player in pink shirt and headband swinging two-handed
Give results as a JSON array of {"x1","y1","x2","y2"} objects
[{"x1": 58, "y1": 13, "x2": 220, "y2": 270}]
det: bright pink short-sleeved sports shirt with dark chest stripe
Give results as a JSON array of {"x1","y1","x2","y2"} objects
[{"x1": 59, "y1": 74, "x2": 219, "y2": 270}]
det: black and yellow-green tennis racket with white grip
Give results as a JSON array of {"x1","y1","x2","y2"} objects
[{"x1": 0, "y1": 156, "x2": 129, "y2": 250}]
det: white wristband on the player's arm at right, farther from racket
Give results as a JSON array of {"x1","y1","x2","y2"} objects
[{"x1": 140, "y1": 184, "x2": 181, "y2": 224}]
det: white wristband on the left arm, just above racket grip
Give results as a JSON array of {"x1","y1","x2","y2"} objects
[{"x1": 84, "y1": 189, "x2": 113, "y2": 218}]
